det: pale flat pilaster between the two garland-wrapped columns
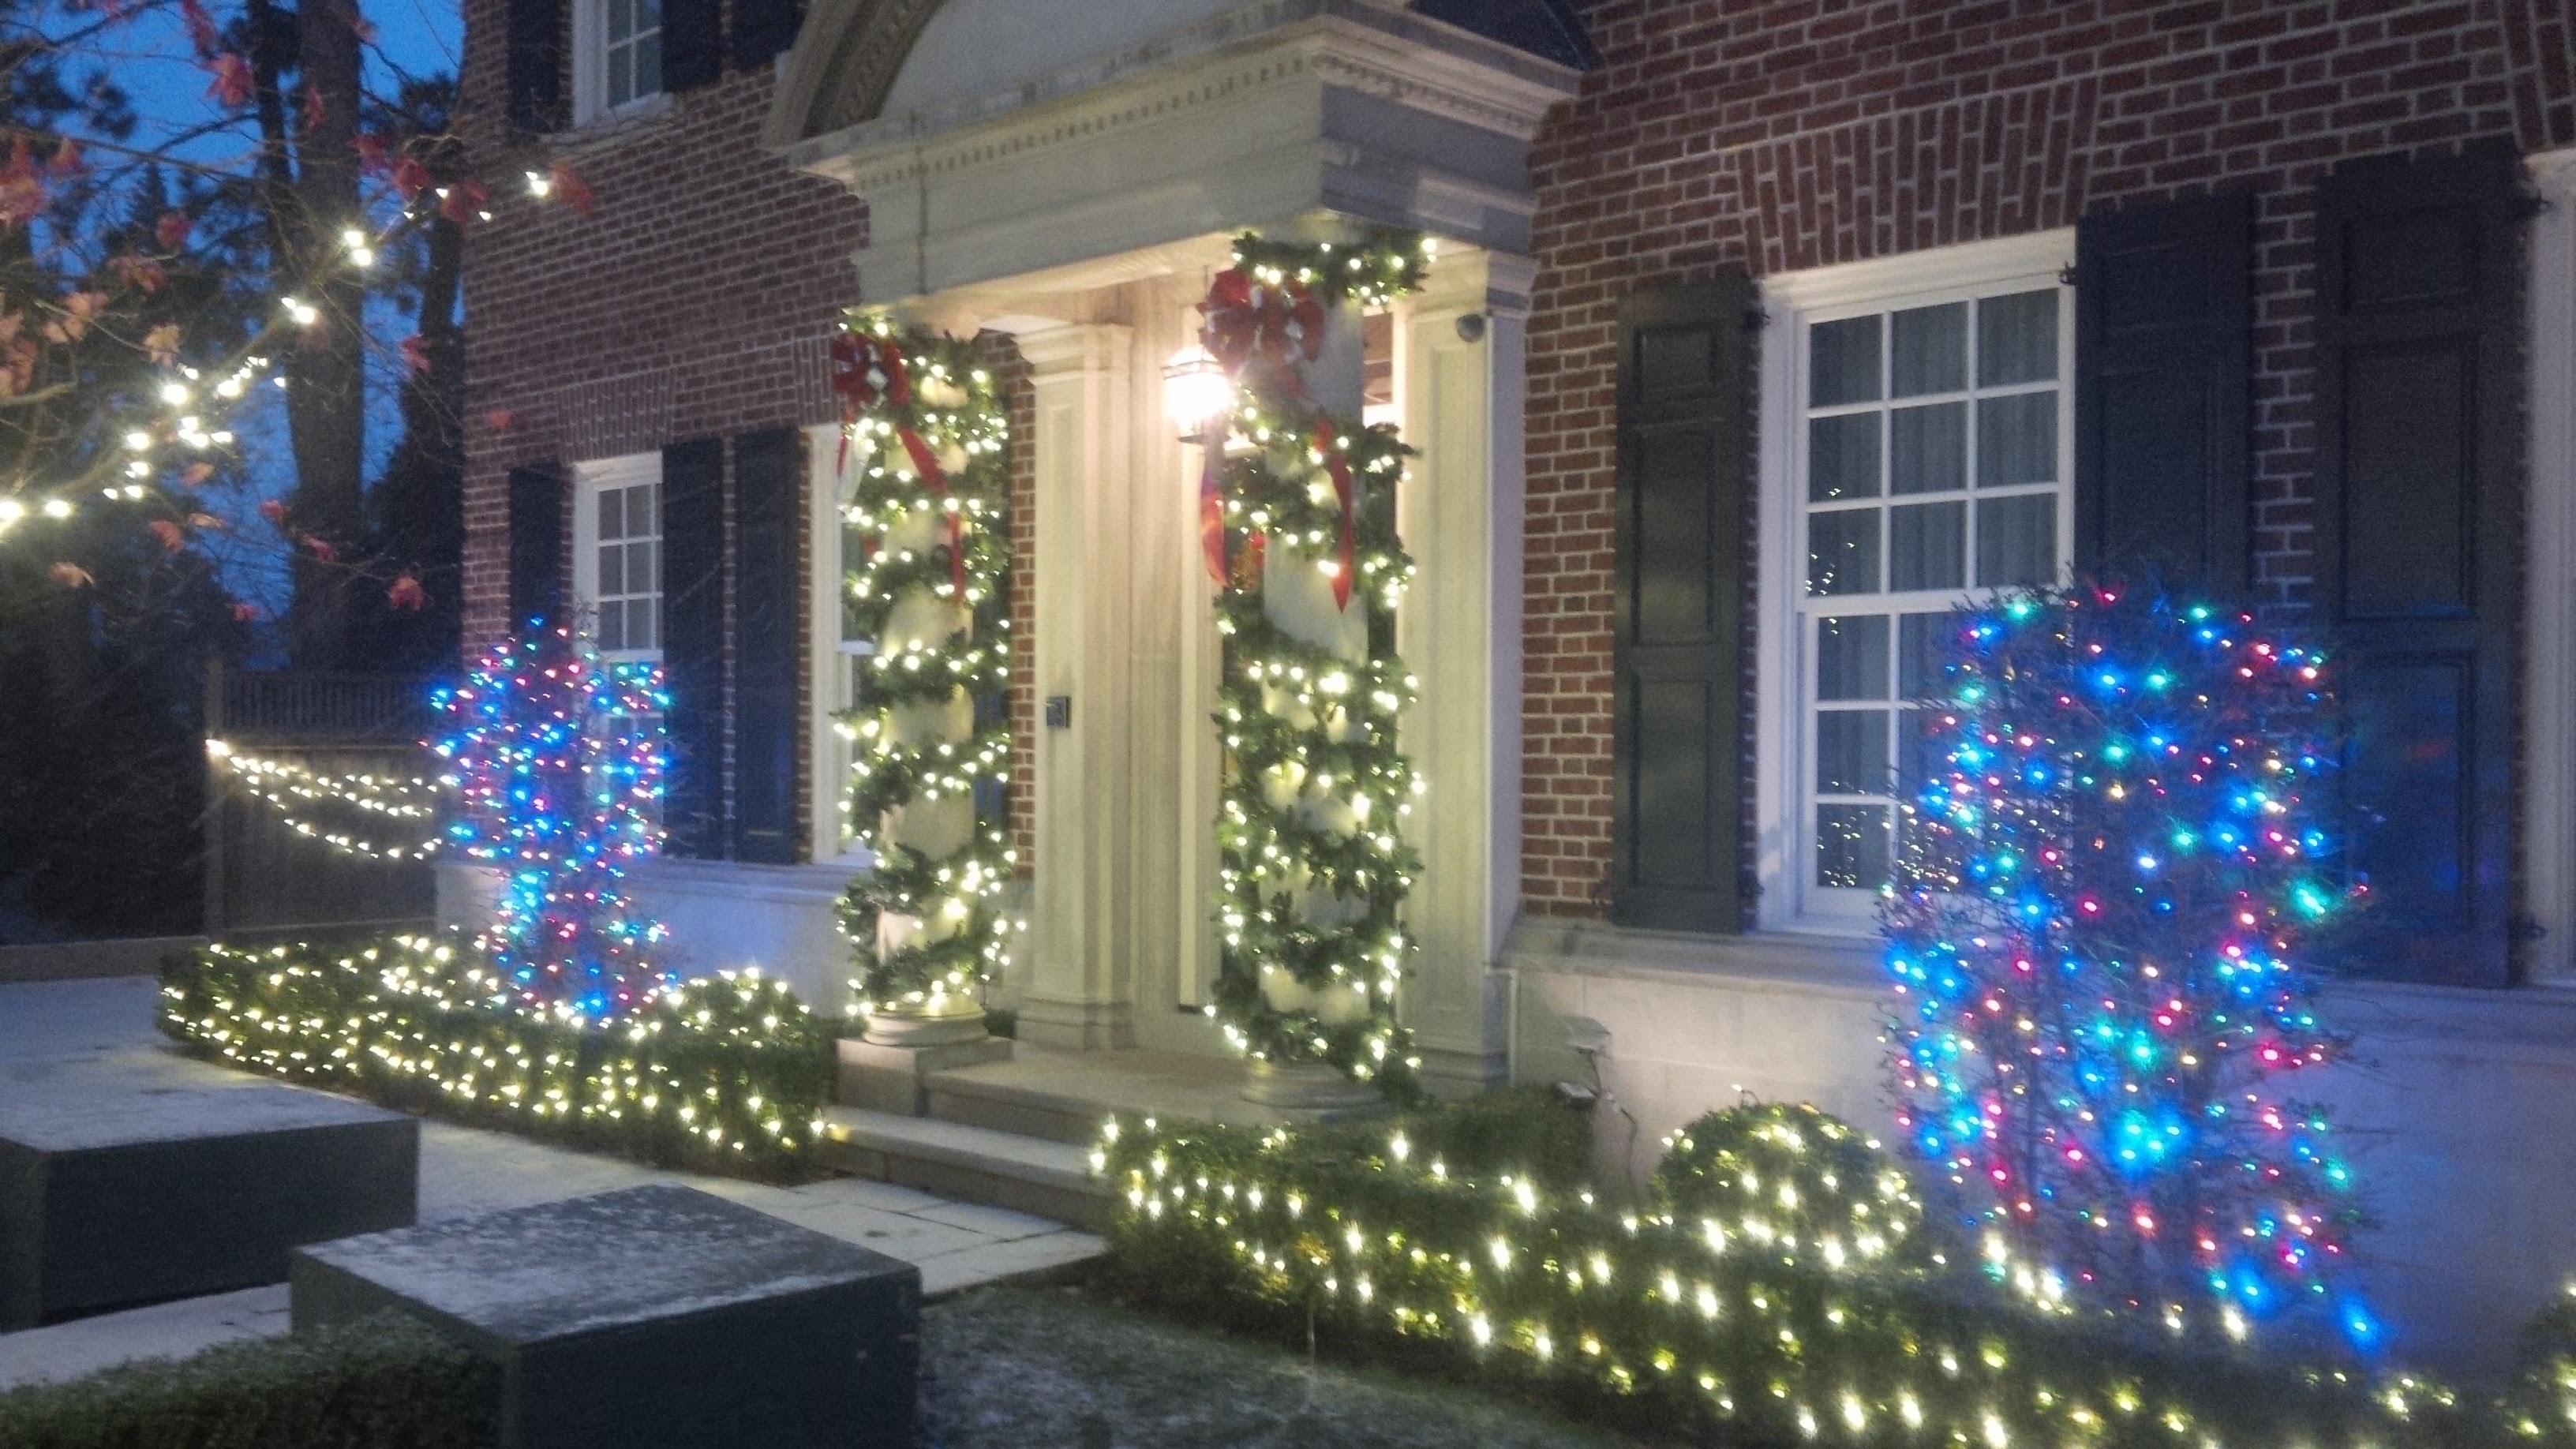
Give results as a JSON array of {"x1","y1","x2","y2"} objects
[{"x1": 1020, "y1": 322, "x2": 1136, "y2": 1046}]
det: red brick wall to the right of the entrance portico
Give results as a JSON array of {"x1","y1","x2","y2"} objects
[{"x1": 1522, "y1": 0, "x2": 2576, "y2": 915}]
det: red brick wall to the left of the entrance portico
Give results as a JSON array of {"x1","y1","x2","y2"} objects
[{"x1": 459, "y1": 0, "x2": 866, "y2": 856}]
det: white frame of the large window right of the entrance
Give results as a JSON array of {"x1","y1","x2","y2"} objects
[{"x1": 1754, "y1": 227, "x2": 2076, "y2": 936}]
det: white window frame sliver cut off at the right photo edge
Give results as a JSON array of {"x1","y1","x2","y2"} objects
[{"x1": 2522, "y1": 149, "x2": 2576, "y2": 983}]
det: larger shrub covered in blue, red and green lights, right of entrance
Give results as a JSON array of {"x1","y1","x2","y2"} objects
[{"x1": 1885, "y1": 590, "x2": 2380, "y2": 1349}]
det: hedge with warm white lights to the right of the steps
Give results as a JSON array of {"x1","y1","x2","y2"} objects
[{"x1": 1095, "y1": 1106, "x2": 2576, "y2": 1449}]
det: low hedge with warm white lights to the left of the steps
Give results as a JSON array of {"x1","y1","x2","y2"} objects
[{"x1": 159, "y1": 936, "x2": 835, "y2": 1178}]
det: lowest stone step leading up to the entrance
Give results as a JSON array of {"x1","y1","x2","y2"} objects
[{"x1": 819, "y1": 1106, "x2": 1113, "y2": 1233}]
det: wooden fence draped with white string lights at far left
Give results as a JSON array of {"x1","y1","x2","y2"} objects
[{"x1": 206, "y1": 665, "x2": 438, "y2": 938}]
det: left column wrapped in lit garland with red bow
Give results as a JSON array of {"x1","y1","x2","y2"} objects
[{"x1": 832, "y1": 315, "x2": 1015, "y2": 1046}]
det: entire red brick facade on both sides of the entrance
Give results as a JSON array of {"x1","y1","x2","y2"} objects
[{"x1": 466, "y1": 0, "x2": 2576, "y2": 915}]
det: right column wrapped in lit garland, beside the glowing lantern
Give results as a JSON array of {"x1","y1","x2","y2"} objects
[{"x1": 1200, "y1": 234, "x2": 1430, "y2": 1101}]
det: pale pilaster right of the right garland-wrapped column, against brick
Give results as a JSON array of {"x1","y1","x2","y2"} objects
[{"x1": 1396, "y1": 248, "x2": 1535, "y2": 1095}]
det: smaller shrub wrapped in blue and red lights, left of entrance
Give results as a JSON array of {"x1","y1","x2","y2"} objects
[{"x1": 430, "y1": 624, "x2": 675, "y2": 1024}]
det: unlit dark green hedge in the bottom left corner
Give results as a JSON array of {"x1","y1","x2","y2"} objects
[{"x1": 0, "y1": 1315, "x2": 500, "y2": 1449}]
